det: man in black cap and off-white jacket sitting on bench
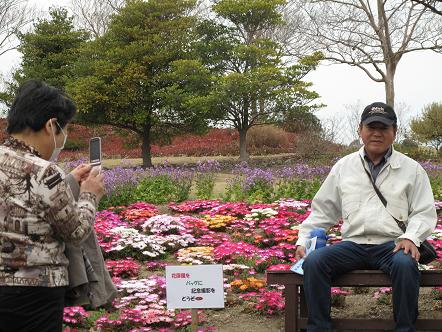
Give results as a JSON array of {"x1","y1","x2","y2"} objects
[{"x1": 296, "y1": 103, "x2": 437, "y2": 332}]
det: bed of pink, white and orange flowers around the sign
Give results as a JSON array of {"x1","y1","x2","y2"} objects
[{"x1": 64, "y1": 199, "x2": 442, "y2": 331}]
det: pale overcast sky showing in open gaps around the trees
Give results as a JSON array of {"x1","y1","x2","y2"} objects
[{"x1": 0, "y1": 0, "x2": 442, "y2": 144}]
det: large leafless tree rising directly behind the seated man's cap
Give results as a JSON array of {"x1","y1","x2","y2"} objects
[{"x1": 292, "y1": 0, "x2": 442, "y2": 106}]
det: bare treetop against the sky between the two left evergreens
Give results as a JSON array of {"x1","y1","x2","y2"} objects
[{"x1": 70, "y1": 0, "x2": 126, "y2": 38}]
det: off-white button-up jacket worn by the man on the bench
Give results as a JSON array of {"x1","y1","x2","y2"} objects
[{"x1": 296, "y1": 147, "x2": 437, "y2": 246}]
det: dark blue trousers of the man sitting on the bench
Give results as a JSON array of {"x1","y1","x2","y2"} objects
[{"x1": 303, "y1": 241, "x2": 420, "y2": 332}]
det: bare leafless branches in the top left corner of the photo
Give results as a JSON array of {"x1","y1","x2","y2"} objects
[{"x1": 0, "y1": 0, "x2": 33, "y2": 55}]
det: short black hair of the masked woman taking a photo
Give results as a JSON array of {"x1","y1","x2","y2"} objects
[{"x1": 6, "y1": 80, "x2": 77, "y2": 134}]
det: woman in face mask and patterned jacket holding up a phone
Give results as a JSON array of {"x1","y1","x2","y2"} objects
[{"x1": 0, "y1": 80, "x2": 104, "y2": 332}]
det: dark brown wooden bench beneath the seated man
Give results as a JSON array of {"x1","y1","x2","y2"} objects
[{"x1": 267, "y1": 270, "x2": 442, "y2": 332}]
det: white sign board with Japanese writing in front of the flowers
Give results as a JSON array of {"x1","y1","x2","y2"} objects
[{"x1": 166, "y1": 265, "x2": 224, "y2": 309}]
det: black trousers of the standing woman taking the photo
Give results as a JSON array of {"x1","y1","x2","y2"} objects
[{"x1": 0, "y1": 286, "x2": 66, "y2": 332}]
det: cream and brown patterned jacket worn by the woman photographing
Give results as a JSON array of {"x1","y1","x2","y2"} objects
[{"x1": 0, "y1": 137, "x2": 96, "y2": 287}]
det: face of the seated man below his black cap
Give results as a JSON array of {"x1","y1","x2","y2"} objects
[{"x1": 359, "y1": 122, "x2": 396, "y2": 156}]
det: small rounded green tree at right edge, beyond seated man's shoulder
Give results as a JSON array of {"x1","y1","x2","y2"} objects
[{"x1": 410, "y1": 103, "x2": 442, "y2": 150}]
